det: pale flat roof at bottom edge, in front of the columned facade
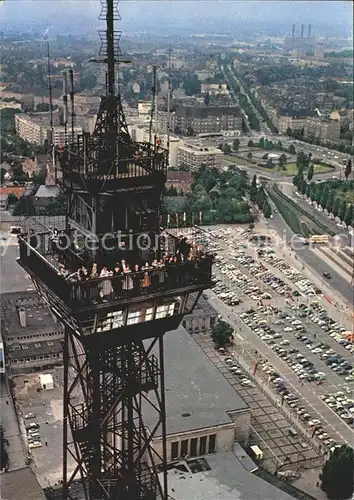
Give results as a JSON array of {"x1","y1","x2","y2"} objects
[{"x1": 159, "y1": 451, "x2": 294, "y2": 500}]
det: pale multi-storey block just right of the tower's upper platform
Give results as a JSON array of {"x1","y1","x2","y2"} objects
[{"x1": 177, "y1": 141, "x2": 223, "y2": 172}]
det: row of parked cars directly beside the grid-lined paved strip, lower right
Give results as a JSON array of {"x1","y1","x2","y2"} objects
[{"x1": 261, "y1": 361, "x2": 339, "y2": 451}]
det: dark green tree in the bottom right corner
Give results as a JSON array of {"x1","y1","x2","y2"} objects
[{"x1": 320, "y1": 445, "x2": 354, "y2": 500}]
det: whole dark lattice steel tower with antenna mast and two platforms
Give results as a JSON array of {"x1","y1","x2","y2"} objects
[{"x1": 19, "y1": 0, "x2": 213, "y2": 500}]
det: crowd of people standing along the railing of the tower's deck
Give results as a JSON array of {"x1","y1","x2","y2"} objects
[{"x1": 54, "y1": 237, "x2": 212, "y2": 302}]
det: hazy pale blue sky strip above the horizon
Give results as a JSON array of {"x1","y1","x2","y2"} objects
[{"x1": 0, "y1": 0, "x2": 353, "y2": 31}]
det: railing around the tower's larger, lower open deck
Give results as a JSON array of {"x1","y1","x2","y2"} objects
[{"x1": 19, "y1": 234, "x2": 213, "y2": 308}]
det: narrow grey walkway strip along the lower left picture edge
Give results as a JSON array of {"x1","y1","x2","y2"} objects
[{"x1": 0, "y1": 379, "x2": 27, "y2": 471}]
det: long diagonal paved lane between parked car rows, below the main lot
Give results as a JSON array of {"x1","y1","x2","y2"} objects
[{"x1": 207, "y1": 291, "x2": 354, "y2": 446}]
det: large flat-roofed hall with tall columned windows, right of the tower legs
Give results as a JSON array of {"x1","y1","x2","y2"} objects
[{"x1": 144, "y1": 326, "x2": 251, "y2": 463}]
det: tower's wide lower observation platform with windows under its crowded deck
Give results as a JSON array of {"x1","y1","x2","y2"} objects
[{"x1": 18, "y1": 229, "x2": 213, "y2": 343}]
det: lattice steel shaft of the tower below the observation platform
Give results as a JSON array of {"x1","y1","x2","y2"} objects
[{"x1": 63, "y1": 328, "x2": 166, "y2": 500}]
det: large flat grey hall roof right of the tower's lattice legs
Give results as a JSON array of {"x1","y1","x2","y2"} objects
[{"x1": 143, "y1": 327, "x2": 249, "y2": 435}]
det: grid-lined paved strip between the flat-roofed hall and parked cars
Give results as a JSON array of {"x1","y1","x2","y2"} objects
[{"x1": 193, "y1": 334, "x2": 325, "y2": 495}]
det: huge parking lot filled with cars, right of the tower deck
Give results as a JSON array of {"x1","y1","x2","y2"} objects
[{"x1": 181, "y1": 228, "x2": 354, "y2": 450}]
